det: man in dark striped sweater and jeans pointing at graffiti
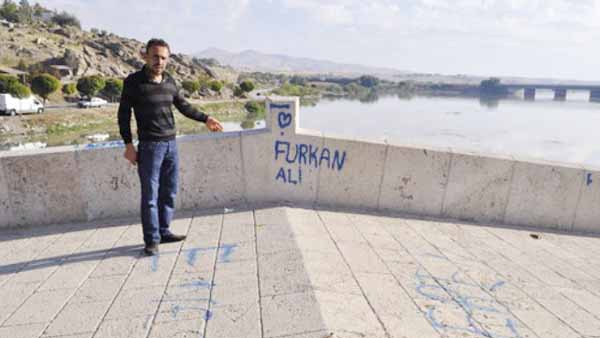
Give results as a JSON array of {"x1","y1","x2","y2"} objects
[{"x1": 118, "y1": 39, "x2": 223, "y2": 255}]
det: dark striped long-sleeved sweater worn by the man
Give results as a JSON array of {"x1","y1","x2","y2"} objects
[{"x1": 119, "y1": 66, "x2": 208, "y2": 144}]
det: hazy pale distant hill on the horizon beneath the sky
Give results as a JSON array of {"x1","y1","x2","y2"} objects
[{"x1": 194, "y1": 48, "x2": 405, "y2": 75}]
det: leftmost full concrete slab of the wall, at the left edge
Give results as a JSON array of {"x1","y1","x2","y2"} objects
[{"x1": 1, "y1": 152, "x2": 87, "y2": 225}]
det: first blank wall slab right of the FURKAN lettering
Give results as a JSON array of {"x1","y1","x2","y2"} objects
[{"x1": 379, "y1": 144, "x2": 450, "y2": 216}]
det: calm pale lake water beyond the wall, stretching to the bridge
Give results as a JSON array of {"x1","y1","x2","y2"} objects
[{"x1": 300, "y1": 92, "x2": 600, "y2": 166}]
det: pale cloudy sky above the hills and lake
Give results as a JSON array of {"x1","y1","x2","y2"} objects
[{"x1": 36, "y1": 0, "x2": 600, "y2": 81}]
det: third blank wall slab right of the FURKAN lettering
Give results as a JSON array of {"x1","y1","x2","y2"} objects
[{"x1": 504, "y1": 158, "x2": 584, "y2": 230}]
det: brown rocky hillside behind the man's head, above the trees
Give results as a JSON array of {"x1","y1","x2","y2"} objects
[{"x1": 0, "y1": 22, "x2": 237, "y2": 82}]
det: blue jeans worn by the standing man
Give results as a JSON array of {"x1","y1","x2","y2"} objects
[{"x1": 138, "y1": 140, "x2": 179, "y2": 244}]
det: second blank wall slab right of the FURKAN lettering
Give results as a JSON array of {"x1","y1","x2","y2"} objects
[{"x1": 442, "y1": 153, "x2": 515, "y2": 223}]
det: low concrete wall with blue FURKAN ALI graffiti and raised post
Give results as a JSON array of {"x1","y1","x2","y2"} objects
[{"x1": 0, "y1": 98, "x2": 600, "y2": 233}]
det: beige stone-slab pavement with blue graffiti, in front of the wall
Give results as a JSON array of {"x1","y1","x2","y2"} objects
[{"x1": 0, "y1": 207, "x2": 600, "y2": 338}]
